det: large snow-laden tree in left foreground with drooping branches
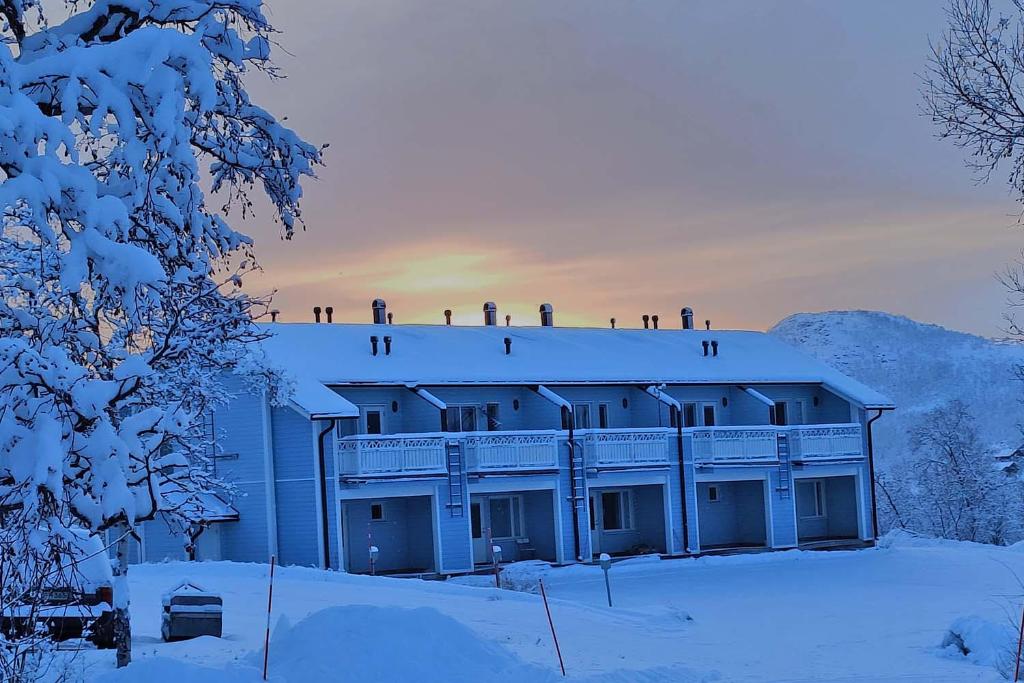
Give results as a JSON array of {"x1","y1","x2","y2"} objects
[{"x1": 0, "y1": 0, "x2": 322, "y2": 665}]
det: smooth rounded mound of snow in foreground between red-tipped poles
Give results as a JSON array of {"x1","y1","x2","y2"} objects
[{"x1": 252, "y1": 605, "x2": 556, "y2": 683}]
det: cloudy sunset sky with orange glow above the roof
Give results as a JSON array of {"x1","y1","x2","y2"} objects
[{"x1": 237, "y1": 0, "x2": 1024, "y2": 335}]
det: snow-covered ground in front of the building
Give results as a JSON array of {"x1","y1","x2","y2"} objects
[{"x1": 68, "y1": 540, "x2": 1024, "y2": 683}]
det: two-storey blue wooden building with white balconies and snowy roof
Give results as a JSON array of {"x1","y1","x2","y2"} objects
[{"x1": 141, "y1": 300, "x2": 894, "y2": 574}]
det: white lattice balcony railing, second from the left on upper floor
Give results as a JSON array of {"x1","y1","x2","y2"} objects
[{"x1": 462, "y1": 431, "x2": 558, "y2": 472}]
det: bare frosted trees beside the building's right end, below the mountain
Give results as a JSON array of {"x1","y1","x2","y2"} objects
[{"x1": 878, "y1": 401, "x2": 1024, "y2": 545}]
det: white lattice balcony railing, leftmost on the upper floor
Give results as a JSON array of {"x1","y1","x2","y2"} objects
[{"x1": 338, "y1": 434, "x2": 446, "y2": 476}]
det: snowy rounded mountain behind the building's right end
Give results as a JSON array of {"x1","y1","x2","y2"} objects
[{"x1": 769, "y1": 310, "x2": 1024, "y2": 461}]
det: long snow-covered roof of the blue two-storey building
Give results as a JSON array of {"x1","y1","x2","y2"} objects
[{"x1": 262, "y1": 323, "x2": 894, "y2": 415}]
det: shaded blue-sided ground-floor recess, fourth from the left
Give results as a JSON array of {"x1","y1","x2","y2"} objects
[{"x1": 697, "y1": 479, "x2": 768, "y2": 550}]
